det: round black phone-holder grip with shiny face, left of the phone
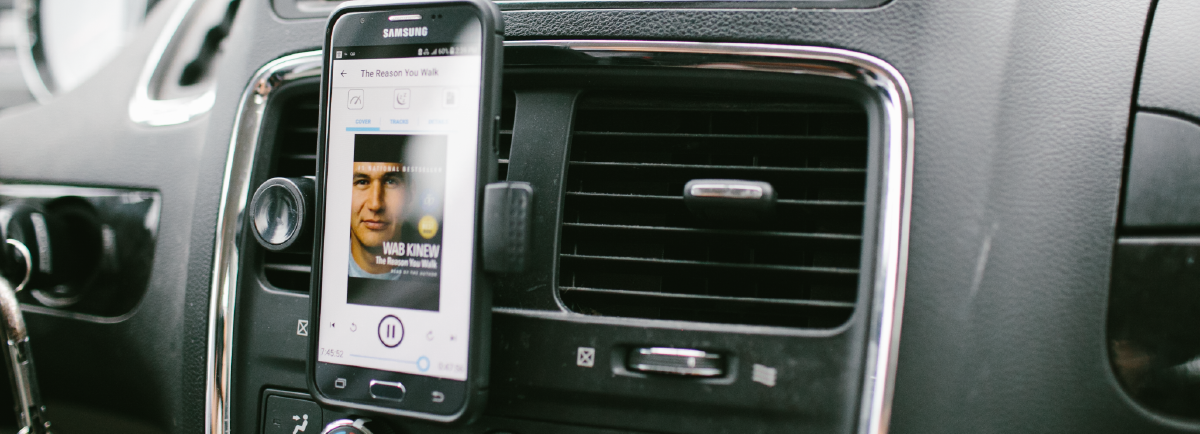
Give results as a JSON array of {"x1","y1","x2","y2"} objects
[{"x1": 248, "y1": 177, "x2": 316, "y2": 252}]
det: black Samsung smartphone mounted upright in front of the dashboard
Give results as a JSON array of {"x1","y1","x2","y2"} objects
[{"x1": 307, "y1": 0, "x2": 503, "y2": 422}]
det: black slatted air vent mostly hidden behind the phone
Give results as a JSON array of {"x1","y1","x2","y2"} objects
[{"x1": 263, "y1": 91, "x2": 516, "y2": 291}]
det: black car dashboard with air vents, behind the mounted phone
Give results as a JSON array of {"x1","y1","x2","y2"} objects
[{"x1": 0, "y1": 0, "x2": 1200, "y2": 434}]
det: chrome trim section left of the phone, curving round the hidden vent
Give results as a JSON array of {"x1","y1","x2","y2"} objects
[{"x1": 204, "y1": 52, "x2": 322, "y2": 433}]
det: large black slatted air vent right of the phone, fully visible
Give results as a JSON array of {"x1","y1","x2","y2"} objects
[{"x1": 559, "y1": 94, "x2": 868, "y2": 328}]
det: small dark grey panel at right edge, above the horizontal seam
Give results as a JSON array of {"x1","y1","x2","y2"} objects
[{"x1": 1123, "y1": 113, "x2": 1200, "y2": 228}]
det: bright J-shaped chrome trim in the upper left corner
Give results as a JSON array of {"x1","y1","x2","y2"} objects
[{"x1": 130, "y1": 0, "x2": 217, "y2": 127}]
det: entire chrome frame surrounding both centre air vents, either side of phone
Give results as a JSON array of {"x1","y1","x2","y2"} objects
[{"x1": 205, "y1": 41, "x2": 913, "y2": 434}]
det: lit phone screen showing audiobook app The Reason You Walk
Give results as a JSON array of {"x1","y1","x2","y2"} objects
[{"x1": 318, "y1": 16, "x2": 481, "y2": 380}]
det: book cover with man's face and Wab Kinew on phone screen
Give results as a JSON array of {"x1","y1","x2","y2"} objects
[{"x1": 347, "y1": 134, "x2": 446, "y2": 311}]
